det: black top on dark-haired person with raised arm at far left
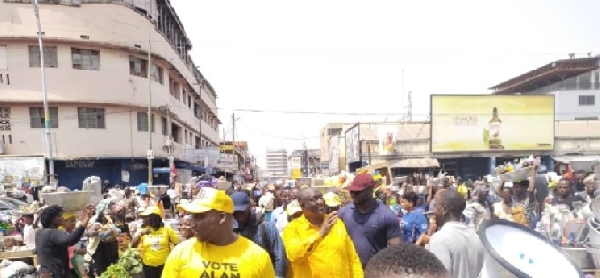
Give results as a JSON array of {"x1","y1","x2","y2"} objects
[{"x1": 35, "y1": 227, "x2": 85, "y2": 277}]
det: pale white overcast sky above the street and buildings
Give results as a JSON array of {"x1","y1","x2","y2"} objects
[{"x1": 171, "y1": 0, "x2": 600, "y2": 165}]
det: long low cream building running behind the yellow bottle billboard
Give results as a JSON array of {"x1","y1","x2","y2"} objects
[{"x1": 321, "y1": 120, "x2": 600, "y2": 175}]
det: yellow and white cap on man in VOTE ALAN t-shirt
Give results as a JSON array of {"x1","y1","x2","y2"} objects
[{"x1": 177, "y1": 187, "x2": 233, "y2": 214}]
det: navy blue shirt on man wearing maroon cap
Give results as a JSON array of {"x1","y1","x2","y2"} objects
[{"x1": 338, "y1": 202, "x2": 402, "y2": 268}]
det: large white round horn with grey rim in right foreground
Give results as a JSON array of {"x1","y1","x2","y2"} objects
[{"x1": 478, "y1": 220, "x2": 584, "y2": 278}]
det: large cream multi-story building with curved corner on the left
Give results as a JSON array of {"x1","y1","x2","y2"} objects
[{"x1": 0, "y1": 0, "x2": 220, "y2": 187}]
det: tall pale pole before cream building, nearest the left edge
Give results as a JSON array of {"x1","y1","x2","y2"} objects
[{"x1": 32, "y1": 0, "x2": 55, "y2": 186}]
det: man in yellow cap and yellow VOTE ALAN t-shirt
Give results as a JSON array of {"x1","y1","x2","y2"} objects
[{"x1": 162, "y1": 187, "x2": 275, "y2": 278}]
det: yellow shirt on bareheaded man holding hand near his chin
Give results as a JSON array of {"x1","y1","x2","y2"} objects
[{"x1": 283, "y1": 215, "x2": 363, "y2": 278}]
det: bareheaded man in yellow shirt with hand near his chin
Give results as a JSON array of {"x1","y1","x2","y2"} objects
[{"x1": 283, "y1": 187, "x2": 363, "y2": 278}]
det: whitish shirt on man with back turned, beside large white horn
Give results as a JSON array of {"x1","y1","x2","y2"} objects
[{"x1": 429, "y1": 222, "x2": 486, "y2": 278}]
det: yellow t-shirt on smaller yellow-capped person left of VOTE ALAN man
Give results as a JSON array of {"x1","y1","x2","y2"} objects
[{"x1": 140, "y1": 227, "x2": 179, "y2": 266}]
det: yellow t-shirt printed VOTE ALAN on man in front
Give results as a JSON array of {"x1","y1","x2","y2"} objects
[{"x1": 162, "y1": 236, "x2": 275, "y2": 278}]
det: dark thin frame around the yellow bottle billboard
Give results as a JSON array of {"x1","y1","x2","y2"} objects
[{"x1": 429, "y1": 94, "x2": 556, "y2": 155}]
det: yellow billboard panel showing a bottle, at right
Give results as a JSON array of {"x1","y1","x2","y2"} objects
[{"x1": 430, "y1": 95, "x2": 554, "y2": 153}]
